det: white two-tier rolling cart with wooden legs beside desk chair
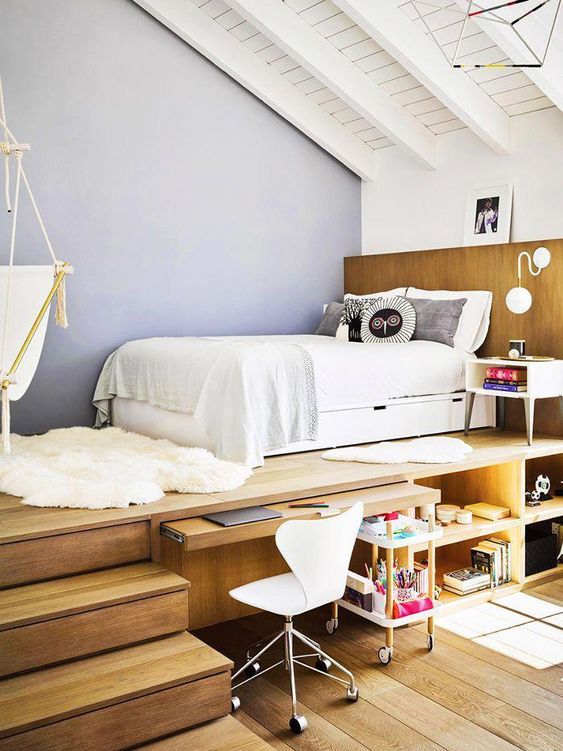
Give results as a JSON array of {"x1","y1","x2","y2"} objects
[{"x1": 326, "y1": 509, "x2": 443, "y2": 665}]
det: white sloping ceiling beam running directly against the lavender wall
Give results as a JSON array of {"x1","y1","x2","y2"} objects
[{"x1": 135, "y1": 0, "x2": 375, "y2": 180}]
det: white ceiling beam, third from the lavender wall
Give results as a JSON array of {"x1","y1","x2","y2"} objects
[{"x1": 334, "y1": 0, "x2": 510, "y2": 154}]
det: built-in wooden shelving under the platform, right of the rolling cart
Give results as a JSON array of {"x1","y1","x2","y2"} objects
[{"x1": 344, "y1": 438, "x2": 563, "y2": 615}]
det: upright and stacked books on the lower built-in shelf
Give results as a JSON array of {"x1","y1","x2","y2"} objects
[{"x1": 444, "y1": 537, "x2": 512, "y2": 595}]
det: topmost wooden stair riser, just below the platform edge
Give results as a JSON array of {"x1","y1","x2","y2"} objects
[{"x1": 0, "y1": 520, "x2": 151, "y2": 587}]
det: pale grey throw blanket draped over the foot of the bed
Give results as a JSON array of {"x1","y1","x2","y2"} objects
[{"x1": 93, "y1": 337, "x2": 318, "y2": 467}]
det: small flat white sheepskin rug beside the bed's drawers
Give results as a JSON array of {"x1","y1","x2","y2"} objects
[{"x1": 322, "y1": 436, "x2": 473, "y2": 464}]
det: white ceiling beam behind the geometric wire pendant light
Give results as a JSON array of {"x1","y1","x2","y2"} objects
[{"x1": 456, "y1": 0, "x2": 563, "y2": 110}]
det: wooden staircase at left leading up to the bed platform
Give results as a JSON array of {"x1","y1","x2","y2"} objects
[{"x1": 0, "y1": 524, "x2": 235, "y2": 751}]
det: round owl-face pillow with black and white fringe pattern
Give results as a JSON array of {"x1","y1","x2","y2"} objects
[{"x1": 361, "y1": 297, "x2": 416, "y2": 344}]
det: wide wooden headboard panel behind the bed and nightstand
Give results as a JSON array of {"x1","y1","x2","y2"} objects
[{"x1": 344, "y1": 240, "x2": 563, "y2": 435}]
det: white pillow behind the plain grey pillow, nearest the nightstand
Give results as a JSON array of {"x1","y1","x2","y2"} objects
[{"x1": 406, "y1": 287, "x2": 493, "y2": 352}]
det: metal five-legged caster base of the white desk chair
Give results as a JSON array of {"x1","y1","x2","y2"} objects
[{"x1": 231, "y1": 616, "x2": 359, "y2": 733}]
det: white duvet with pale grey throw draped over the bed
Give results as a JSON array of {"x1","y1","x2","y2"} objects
[{"x1": 94, "y1": 335, "x2": 467, "y2": 466}]
